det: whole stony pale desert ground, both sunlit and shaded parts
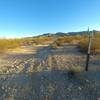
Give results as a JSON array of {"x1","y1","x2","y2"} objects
[{"x1": 0, "y1": 44, "x2": 100, "y2": 100}]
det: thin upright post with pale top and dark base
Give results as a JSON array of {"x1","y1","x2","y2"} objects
[{"x1": 85, "y1": 28, "x2": 93, "y2": 71}]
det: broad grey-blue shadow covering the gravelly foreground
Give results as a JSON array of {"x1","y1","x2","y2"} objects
[{"x1": 0, "y1": 70, "x2": 100, "y2": 100}]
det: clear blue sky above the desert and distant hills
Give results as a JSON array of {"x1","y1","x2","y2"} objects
[{"x1": 0, "y1": 0, "x2": 100, "y2": 37}]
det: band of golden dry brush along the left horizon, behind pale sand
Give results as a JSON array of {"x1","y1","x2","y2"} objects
[{"x1": 0, "y1": 36, "x2": 53, "y2": 53}]
